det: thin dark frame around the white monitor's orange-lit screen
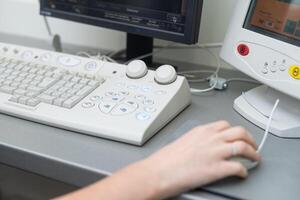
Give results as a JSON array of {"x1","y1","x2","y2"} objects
[{"x1": 243, "y1": 0, "x2": 300, "y2": 47}]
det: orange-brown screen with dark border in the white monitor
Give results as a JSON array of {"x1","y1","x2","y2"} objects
[{"x1": 244, "y1": 0, "x2": 300, "y2": 46}]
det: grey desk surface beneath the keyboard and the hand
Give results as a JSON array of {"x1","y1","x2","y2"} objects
[{"x1": 0, "y1": 33, "x2": 300, "y2": 200}]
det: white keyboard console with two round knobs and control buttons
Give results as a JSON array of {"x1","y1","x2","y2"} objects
[{"x1": 0, "y1": 43, "x2": 191, "y2": 145}]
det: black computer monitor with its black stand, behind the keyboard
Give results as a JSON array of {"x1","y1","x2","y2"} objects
[{"x1": 40, "y1": 0, "x2": 203, "y2": 63}]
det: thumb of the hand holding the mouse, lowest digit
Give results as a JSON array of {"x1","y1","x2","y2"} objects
[{"x1": 221, "y1": 161, "x2": 248, "y2": 178}]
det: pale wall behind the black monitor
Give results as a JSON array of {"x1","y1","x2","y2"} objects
[{"x1": 0, "y1": 0, "x2": 237, "y2": 68}]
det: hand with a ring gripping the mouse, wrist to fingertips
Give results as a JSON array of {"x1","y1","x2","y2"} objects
[{"x1": 142, "y1": 121, "x2": 260, "y2": 199}]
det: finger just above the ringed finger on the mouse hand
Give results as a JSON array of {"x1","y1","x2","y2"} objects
[{"x1": 222, "y1": 127, "x2": 257, "y2": 149}]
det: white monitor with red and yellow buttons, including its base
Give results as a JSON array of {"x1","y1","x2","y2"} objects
[{"x1": 221, "y1": 0, "x2": 300, "y2": 138}]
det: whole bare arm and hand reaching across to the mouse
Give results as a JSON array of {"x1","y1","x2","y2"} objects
[{"x1": 55, "y1": 121, "x2": 260, "y2": 200}]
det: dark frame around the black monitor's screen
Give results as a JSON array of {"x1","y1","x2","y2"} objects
[{"x1": 40, "y1": 0, "x2": 203, "y2": 44}]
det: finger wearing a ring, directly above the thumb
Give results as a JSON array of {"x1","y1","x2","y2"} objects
[{"x1": 220, "y1": 141, "x2": 261, "y2": 161}]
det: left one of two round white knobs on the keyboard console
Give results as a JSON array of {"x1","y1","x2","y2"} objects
[{"x1": 126, "y1": 60, "x2": 148, "y2": 79}]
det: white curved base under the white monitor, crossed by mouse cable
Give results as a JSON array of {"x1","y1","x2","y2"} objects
[{"x1": 234, "y1": 85, "x2": 300, "y2": 138}]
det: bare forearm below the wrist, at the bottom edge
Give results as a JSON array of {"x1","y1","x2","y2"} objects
[{"x1": 58, "y1": 161, "x2": 162, "y2": 200}]
